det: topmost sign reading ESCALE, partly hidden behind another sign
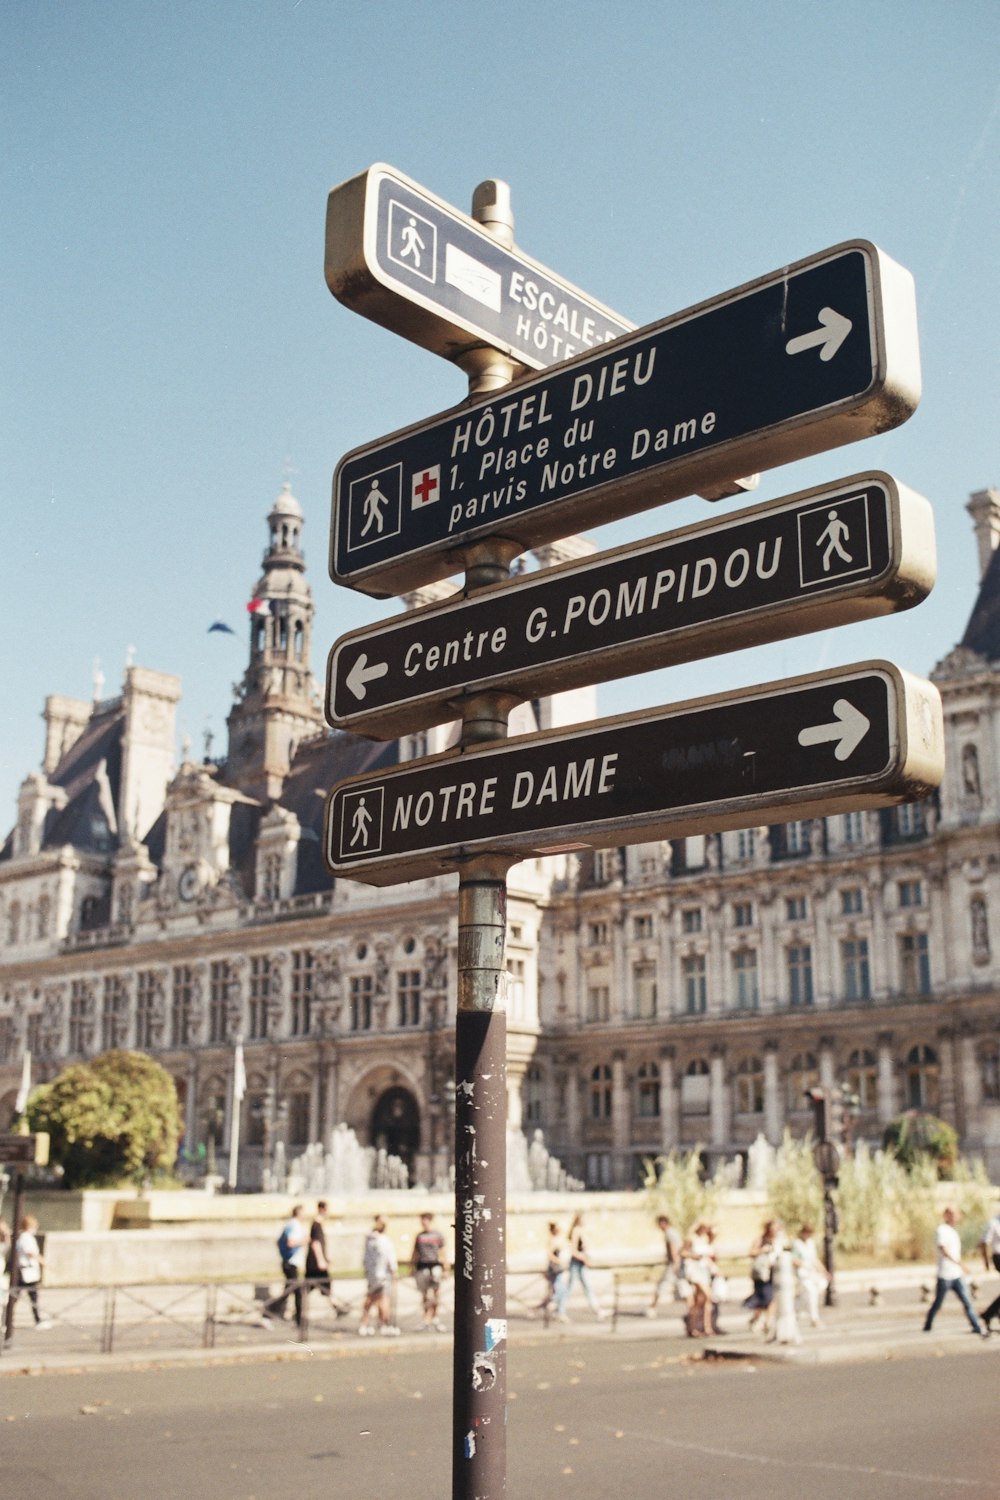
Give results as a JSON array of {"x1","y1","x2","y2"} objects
[{"x1": 325, "y1": 164, "x2": 636, "y2": 371}]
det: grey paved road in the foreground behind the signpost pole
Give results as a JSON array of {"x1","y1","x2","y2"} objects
[{"x1": 0, "y1": 1322, "x2": 1000, "y2": 1500}]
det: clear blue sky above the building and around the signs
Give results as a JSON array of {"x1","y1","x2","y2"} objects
[{"x1": 0, "y1": 0, "x2": 1000, "y2": 830}]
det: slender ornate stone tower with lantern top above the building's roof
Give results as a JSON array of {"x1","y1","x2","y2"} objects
[{"x1": 225, "y1": 482, "x2": 324, "y2": 803}]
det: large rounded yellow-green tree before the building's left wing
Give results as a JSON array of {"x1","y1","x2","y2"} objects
[{"x1": 27, "y1": 1052, "x2": 181, "y2": 1188}]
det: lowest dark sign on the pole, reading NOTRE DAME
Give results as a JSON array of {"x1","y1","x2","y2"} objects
[{"x1": 325, "y1": 662, "x2": 945, "y2": 885}]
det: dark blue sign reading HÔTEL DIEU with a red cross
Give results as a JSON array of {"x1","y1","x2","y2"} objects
[{"x1": 330, "y1": 240, "x2": 921, "y2": 596}]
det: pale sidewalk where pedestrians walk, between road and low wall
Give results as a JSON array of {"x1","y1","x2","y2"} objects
[{"x1": 0, "y1": 1266, "x2": 1000, "y2": 1377}]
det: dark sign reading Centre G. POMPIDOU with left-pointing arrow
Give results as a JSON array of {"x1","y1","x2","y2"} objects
[{"x1": 327, "y1": 473, "x2": 936, "y2": 740}]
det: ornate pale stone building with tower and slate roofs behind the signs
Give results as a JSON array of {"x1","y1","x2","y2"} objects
[{"x1": 0, "y1": 491, "x2": 1000, "y2": 1185}]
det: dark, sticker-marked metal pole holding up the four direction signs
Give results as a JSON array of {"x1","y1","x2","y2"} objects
[{"x1": 451, "y1": 180, "x2": 516, "y2": 1500}]
